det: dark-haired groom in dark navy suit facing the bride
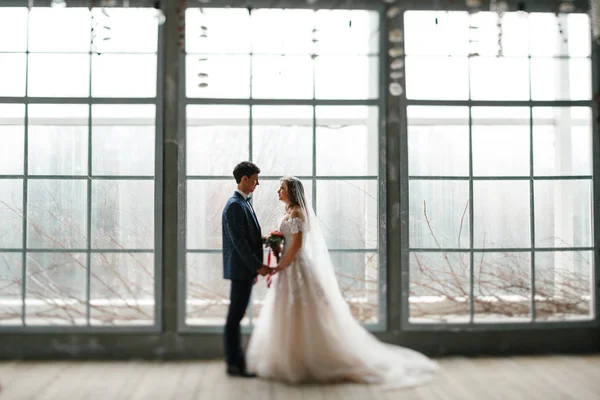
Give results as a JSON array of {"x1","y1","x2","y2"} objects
[{"x1": 221, "y1": 161, "x2": 270, "y2": 378}]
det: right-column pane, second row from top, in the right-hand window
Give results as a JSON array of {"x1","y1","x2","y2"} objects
[{"x1": 531, "y1": 58, "x2": 592, "y2": 100}]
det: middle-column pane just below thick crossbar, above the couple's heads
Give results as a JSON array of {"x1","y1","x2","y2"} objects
[{"x1": 252, "y1": 106, "x2": 313, "y2": 175}]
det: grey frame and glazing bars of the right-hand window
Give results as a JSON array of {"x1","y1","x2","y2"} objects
[{"x1": 398, "y1": 6, "x2": 600, "y2": 332}]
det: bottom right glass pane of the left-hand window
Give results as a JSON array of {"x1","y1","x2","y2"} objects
[{"x1": 90, "y1": 253, "x2": 155, "y2": 325}]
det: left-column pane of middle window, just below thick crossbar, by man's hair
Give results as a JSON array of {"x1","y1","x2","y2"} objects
[{"x1": 186, "y1": 105, "x2": 250, "y2": 179}]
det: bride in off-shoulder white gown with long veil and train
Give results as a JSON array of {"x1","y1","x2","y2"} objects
[{"x1": 247, "y1": 177, "x2": 437, "y2": 388}]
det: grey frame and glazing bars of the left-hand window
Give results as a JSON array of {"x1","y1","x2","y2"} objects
[{"x1": 0, "y1": 0, "x2": 165, "y2": 334}]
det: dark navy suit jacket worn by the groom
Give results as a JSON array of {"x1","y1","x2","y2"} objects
[{"x1": 221, "y1": 192, "x2": 263, "y2": 280}]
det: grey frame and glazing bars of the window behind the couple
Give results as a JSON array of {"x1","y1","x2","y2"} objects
[{"x1": 177, "y1": 1, "x2": 389, "y2": 333}]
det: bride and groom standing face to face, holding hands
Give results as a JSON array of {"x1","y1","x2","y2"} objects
[{"x1": 222, "y1": 162, "x2": 437, "y2": 387}]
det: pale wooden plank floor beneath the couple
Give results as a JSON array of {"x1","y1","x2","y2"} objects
[{"x1": 0, "y1": 355, "x2": 600, "y2": 400}]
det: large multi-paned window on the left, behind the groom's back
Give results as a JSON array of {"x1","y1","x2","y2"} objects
[{"x1": 0, "y1": 7, "x2": 160, "y2": 329}]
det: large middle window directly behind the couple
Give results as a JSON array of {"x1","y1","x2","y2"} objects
[{"x1": 180, "y1": 8, "x2": 385, "y2": 329}]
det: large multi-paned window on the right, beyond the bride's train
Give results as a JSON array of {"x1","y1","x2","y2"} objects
[{"x1": 403, "y1": 11, "x2": 595, "y2": 324}]
